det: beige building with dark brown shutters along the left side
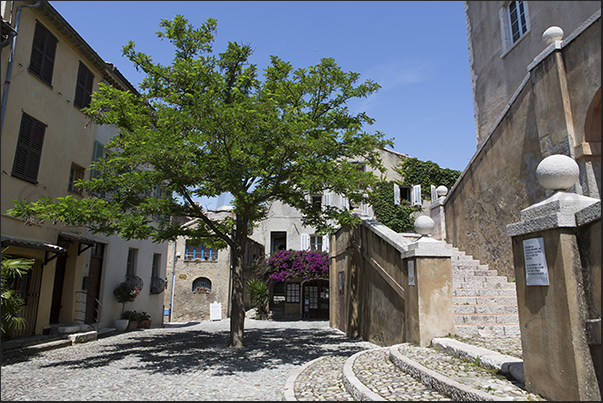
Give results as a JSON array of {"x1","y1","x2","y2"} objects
[{"x1": 1, "y1": 1, "x2": 167, "y2": 337}]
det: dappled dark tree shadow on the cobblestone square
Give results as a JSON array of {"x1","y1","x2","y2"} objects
[{"x1": 35, "y1": 326, "x2": 365, "y2": 375}]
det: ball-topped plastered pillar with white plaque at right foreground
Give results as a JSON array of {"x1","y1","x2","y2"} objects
[{"x1": 507, "y1": 155, "x2": 601, "y2": 401}]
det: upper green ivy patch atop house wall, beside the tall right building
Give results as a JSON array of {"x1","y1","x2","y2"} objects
[{"x1": 394, "y1": 157, "x2": 461, "y2": 198}]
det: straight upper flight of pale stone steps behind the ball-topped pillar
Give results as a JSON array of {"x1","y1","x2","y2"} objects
[{"x1": 451, "y1": 247, "x2": 520, "y2": 337}]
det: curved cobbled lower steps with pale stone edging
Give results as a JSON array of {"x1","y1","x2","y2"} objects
[{"x1": 283, "y1": 338, "x2": 546, "y2": 401}]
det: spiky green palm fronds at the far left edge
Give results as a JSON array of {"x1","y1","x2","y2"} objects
[{"x1": 0, "y1": 249, "x2": 35, "y2": 334}]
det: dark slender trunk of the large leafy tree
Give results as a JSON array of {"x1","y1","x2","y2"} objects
[{"x1": 228, "y1": 219, "x2": 247, "y2": 348}]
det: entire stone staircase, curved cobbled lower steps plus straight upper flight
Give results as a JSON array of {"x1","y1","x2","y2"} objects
[{"x1": 284, "y1": 245, "x2": 546, "y2": 401}]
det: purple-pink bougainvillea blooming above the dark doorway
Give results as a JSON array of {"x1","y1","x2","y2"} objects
[{"x1": 260, "y1": 249, "x2": 329, "y2": 283}]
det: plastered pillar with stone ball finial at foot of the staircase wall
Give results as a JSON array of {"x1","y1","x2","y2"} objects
[{"x1": 401, "y1": 216, "x2": 454, "y2": 347}]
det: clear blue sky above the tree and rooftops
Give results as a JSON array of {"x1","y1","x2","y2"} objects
[{"x1": 50, "y1": 1, "x2": 476, "y2": 208}]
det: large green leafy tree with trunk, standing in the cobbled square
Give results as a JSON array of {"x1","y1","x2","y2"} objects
[{"x1": 11, "y1": 16, "x2": 391, "y2": 347}]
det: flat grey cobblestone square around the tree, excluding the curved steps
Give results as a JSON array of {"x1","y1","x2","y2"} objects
[{"x1": 1, "y1": 319, "x2": 375, "y2": 401}]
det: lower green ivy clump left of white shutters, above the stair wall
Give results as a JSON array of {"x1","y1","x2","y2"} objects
[{"x1": 370, "y1": 181, "x2": 421, "y2": 232}]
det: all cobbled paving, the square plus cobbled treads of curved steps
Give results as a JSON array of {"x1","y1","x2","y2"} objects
[{"x1": 1, "y1": 319, "x2": 544, "y2": 401}]
